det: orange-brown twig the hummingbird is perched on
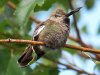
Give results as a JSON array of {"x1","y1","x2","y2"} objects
[{"x1": 0, "y1": 39, "x2": 100, "y2": 54}]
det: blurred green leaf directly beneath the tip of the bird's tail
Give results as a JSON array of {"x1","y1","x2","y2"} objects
[{"x1": 5, "y1": 55, "x2": 32, "y2": 75}]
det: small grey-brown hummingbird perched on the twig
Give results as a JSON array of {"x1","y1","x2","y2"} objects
[{"x1": 18, "y1": 7, "x2": 81, "y2": 67}]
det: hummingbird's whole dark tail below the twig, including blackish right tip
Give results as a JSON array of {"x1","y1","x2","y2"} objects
[{"x1": 18, "y1": 45, "x2": 45, "y2": 67}]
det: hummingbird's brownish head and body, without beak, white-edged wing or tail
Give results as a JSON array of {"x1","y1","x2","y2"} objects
[{"x1": 33, "y1": 9, "x2": 70, "y2": 48}]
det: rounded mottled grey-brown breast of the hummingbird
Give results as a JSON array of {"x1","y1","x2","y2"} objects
[{"x1": 38, "y1": 25, "x2": 68, "y2": 48}]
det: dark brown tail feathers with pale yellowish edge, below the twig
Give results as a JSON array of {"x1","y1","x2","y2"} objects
[{"x1": 18, "y1": 45, "x2": 37, "y2": 67}]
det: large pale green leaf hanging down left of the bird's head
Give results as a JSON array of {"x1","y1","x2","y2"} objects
[{"x1": 14, "y1": 0, "x2": 44, "y2": 36}]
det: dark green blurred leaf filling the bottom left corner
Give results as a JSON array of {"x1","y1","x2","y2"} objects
[{"x1": 0, "y1": 46, "x2": 11, "y2": 75}]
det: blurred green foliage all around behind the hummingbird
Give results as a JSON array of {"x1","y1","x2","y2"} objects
[{"x1": 0, "y1": 0, "x2": 100, "y2": 75}]
